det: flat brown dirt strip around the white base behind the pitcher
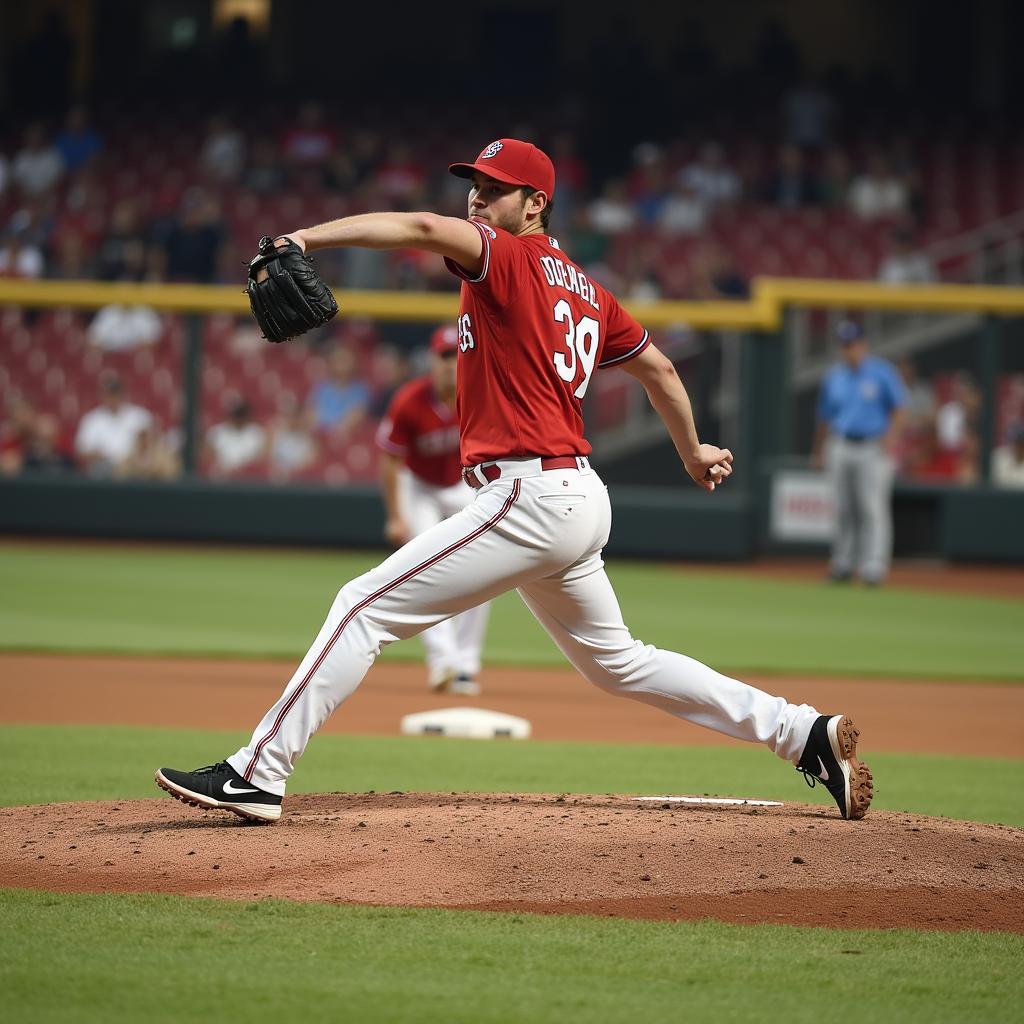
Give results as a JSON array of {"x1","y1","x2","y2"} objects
[{"x1": 0, "y1": 654, "x2": 1024, "y2": 758}]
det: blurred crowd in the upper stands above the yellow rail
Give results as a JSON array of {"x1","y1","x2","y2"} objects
[{"x1": 0, "y1": 89, "x2": 970, "y2": 299}]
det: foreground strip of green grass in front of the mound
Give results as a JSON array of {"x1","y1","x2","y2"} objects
[{"x1": 0, "y1": 890, "x2": 1024, "y2": 1024}]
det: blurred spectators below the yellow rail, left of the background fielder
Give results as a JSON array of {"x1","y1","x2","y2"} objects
[{"x1": 0, "y1": 319, "x2": 426, "y2": 482}]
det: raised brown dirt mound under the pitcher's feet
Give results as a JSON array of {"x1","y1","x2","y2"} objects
[{"x1": 0, "y1": 793, "x2": 1024, "y2": 932}]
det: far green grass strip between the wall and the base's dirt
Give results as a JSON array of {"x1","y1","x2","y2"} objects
[{"x1": 0, "y1": 545, "x2": 1024, "y2": 681}]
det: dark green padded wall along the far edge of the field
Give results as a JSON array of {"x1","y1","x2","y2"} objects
[{"x1": 0, "y1": 477, "x2": 1024, "y2": 562}]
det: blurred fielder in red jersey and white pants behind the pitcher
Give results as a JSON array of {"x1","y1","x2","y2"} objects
[{"x1": 377, "y1": 325, "x2": 489, "y2": 696}]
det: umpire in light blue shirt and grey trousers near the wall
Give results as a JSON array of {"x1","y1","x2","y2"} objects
[{"x1": 811, "y1": 319, "x2": 906, "y2": 586}]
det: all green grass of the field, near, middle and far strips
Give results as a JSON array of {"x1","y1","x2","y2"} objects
[{"x1": 0, "y1": 545, "x2": 1024, "y2": 1024}]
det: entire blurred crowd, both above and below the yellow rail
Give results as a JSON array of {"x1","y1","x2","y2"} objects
[{"x1": 0, "y1": 49, "x2": 1024, "y2": 485}]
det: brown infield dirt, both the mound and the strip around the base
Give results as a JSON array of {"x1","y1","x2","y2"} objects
[{"x1": 0, "y1": 655, "x2": 1024, "y2": 933}]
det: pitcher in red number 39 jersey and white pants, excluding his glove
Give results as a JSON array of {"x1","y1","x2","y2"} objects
[{"x1": 157, "y1": 139, "x2": 871, "y2": 820}]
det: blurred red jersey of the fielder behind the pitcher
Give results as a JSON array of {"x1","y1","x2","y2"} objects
[{"x1": 377, "y1": 376, "x2": 462, "y2": 487}]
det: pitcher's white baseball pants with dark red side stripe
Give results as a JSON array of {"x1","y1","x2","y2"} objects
[{"x1": 228, "y1": 459, "x2": 817, "y2": 794}]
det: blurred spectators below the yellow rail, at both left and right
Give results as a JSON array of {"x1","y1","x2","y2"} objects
[{"x1": 0, "y1": 324, "x2": 1024, "y2": 488}]
